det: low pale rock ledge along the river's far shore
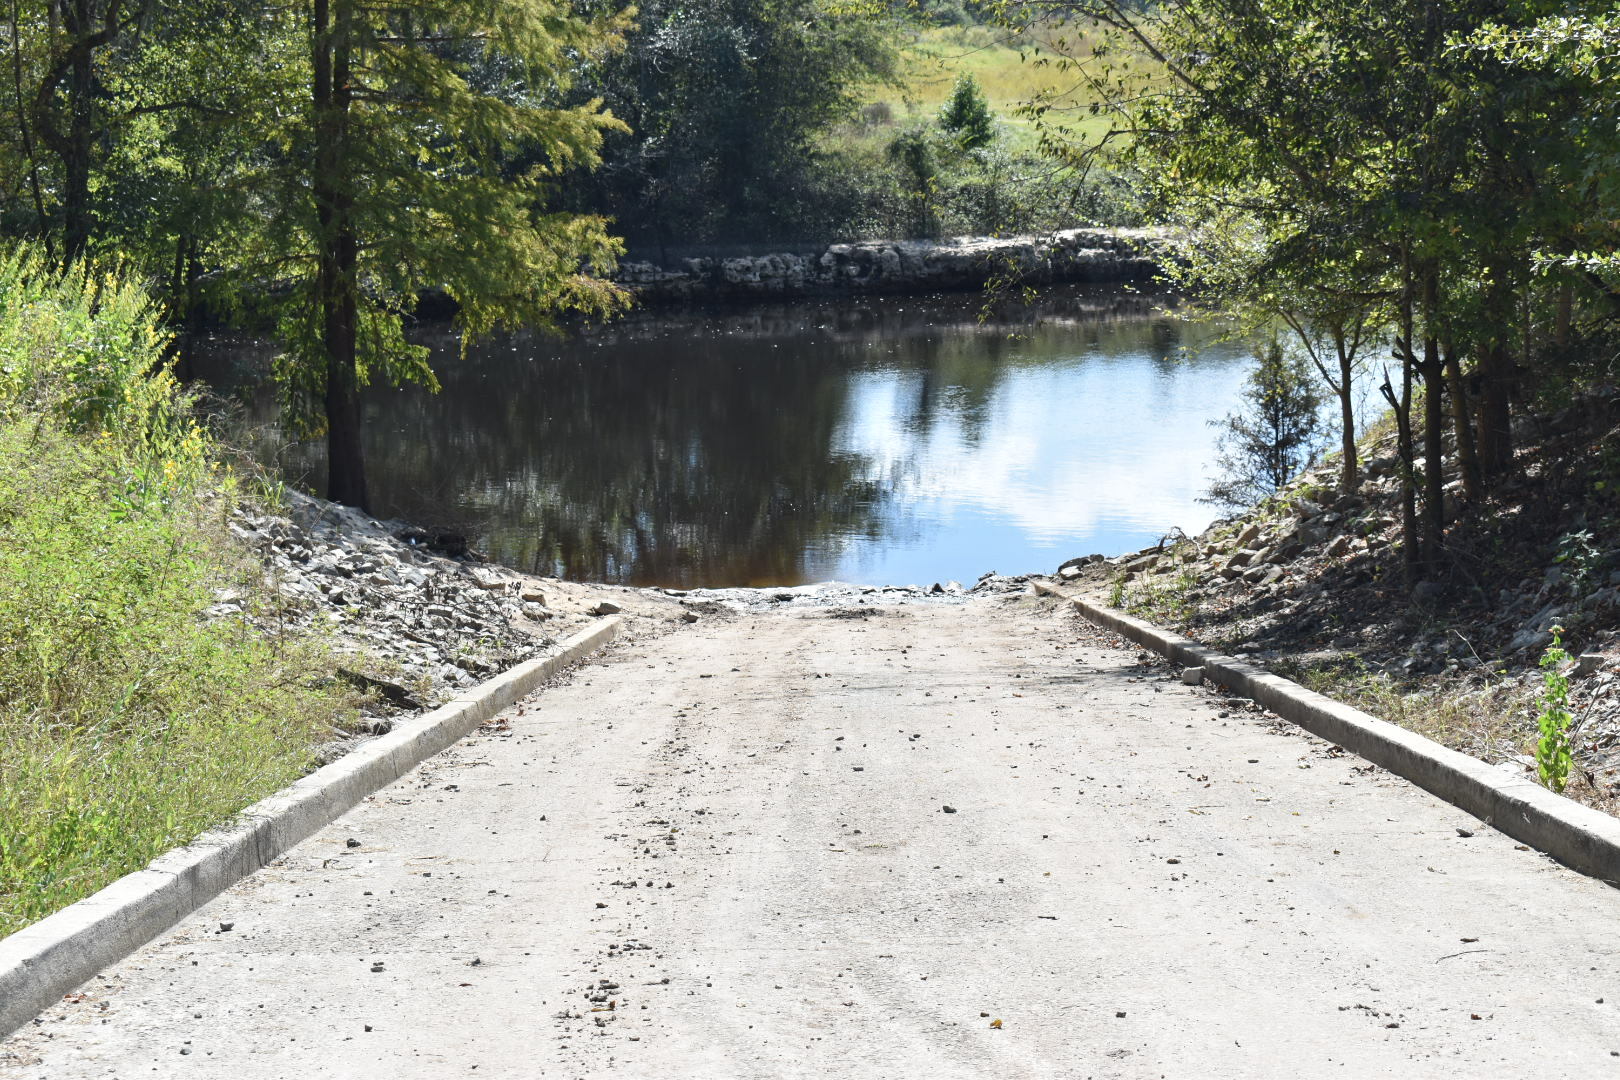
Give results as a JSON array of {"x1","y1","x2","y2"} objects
[{"x1": 616, "y1": 228, "x2": 1166, "y2": 304}]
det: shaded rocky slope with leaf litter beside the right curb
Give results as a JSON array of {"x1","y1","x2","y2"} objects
[{"x1": 1055, "y1": 382, "x2": 1620, "y2": 810}]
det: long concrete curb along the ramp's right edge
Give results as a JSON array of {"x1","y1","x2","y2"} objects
[{"x1": 1035, "y1": 581, "x2": 1620, "y2": 884}]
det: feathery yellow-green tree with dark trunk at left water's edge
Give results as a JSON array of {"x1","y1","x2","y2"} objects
[{"x1": 244, "y1": 0, "x2": 625, "y2": 507}]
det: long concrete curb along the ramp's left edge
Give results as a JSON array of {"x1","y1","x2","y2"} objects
[{"x1": 0, "y1": 619, "x2": 624, "y2": 1038}]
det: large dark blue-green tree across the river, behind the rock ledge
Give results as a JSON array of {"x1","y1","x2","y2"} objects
[{"x1": 570, "y1": 0, "x2": 901, "y2": 244}]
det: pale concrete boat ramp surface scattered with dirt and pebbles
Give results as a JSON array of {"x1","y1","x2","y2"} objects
[{"x1": 0, "y1": 597, "x2": 1620, "y2": 1080}]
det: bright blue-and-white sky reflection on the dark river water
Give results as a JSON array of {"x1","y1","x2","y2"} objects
[{"x1": 813, "y1": 342, "x2": 1243, "y2": 583}]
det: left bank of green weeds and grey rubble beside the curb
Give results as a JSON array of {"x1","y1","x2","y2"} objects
[{"x1": 0, "y1": 253, "x2": 697, "y2": 936}]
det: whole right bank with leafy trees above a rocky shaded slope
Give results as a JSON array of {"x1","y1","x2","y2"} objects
[{"x1": 1003, "y1": 0, "x2": 1620, "y2": 819}]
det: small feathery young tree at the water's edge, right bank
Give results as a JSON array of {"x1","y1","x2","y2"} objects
[{"x1": 1205, "y1": 338, "x2": 1322, "y2": 508}]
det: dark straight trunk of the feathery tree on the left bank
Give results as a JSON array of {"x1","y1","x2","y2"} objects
[{"x1": 311, "y1": 0, "x2": 369, "y2": 508}]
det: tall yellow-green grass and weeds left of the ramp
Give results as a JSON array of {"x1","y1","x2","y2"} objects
[{"x1": 0, "y1": 249, "x2": 343, "y2": 934}]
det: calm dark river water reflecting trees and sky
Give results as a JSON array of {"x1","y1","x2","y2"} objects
[{"x1": 206, "y1": 288, "x2": 1249, "y2": 586}]
